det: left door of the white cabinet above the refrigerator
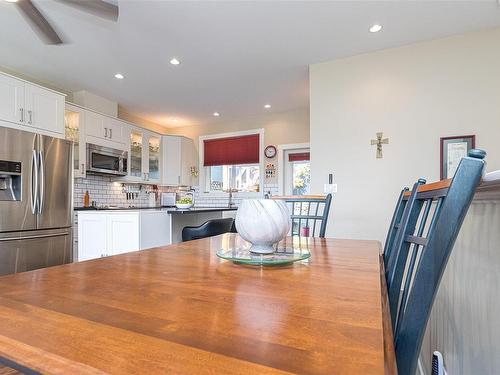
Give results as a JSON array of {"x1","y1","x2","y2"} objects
[{"x1": 0, "y1": 74, "x2": 24, "y2": 124}]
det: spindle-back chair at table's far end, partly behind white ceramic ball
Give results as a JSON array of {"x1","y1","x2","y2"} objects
[{"x1": 271, "y1": 194, "x2": 332, "y2": 237}]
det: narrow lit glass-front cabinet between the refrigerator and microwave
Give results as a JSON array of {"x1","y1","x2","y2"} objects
[{"x1": 64, "y1": 103, "x2": 87, "y2": 177}]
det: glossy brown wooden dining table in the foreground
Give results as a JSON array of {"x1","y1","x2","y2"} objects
[{"x1": 0, "y1": 234, "x2": 396, "y2": 375}]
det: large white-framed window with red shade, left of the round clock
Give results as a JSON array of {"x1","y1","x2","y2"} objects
[{"x1": 200, "y1": 130, "x2": 263, "y2": 193}]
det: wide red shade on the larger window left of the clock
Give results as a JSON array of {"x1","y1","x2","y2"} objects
[{"x1": 203, "y1": 134, "x2": 260, "y2": 167}]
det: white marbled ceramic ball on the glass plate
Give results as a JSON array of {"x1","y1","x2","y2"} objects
[{"x1": 236, "y1": 199, "x2": 291, "y2": 254}]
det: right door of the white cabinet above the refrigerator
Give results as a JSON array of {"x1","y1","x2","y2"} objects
[{"x1": 24, "y1": 83, "x2": 64, "y2": 134}]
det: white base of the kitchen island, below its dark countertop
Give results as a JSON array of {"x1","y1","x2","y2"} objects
[{"x1": 78, "y1": 210, "x2": 171, "y2": 261}]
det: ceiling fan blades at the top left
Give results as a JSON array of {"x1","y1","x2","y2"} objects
[{"x1": 7, "y1": 0, "x2": 118, "y2": 44}]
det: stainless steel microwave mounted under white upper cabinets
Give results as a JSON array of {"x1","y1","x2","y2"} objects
[{"x1": 87, "y1": 143, "x2": 128, "y2": 176}]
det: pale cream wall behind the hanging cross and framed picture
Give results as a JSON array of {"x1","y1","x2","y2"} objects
[{"x1": 310, "y1": 29, "x2": 500, "y2": 240}]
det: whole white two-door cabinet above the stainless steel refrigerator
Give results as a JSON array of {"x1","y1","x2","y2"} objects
[{"x1": 0, "y1": 73, "x2": 64, "y2": 137}]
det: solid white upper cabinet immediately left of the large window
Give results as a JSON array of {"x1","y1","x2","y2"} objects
[{"x1": 161, "y1": 136, "x2": 198, "y2": 186}]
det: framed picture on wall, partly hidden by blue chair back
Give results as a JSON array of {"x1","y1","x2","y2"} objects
[{"x1": 441, "y1": 135, "x2": 476, "y2": 180}]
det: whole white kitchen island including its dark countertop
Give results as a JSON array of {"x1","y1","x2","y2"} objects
[{"x1": 74, "y1": 207, "x2": 237, "y2": 261}]
